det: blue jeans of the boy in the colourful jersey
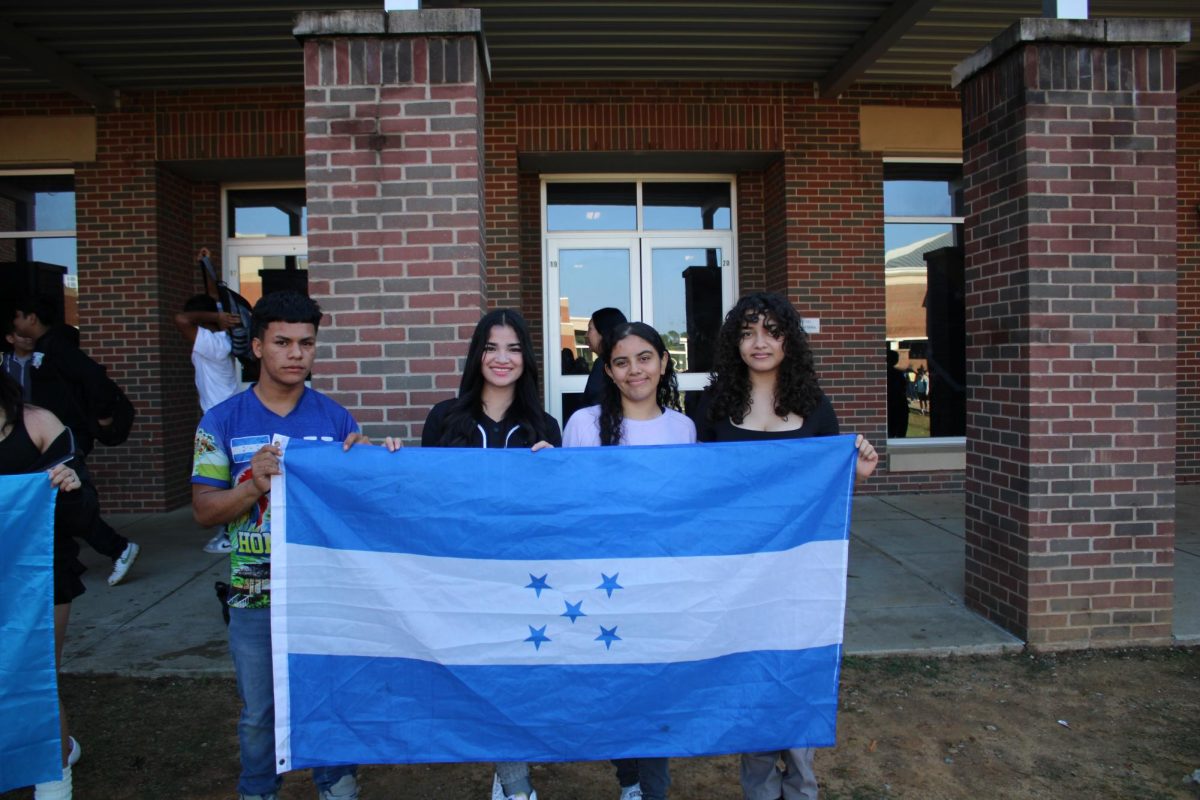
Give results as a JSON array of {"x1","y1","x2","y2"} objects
[{"x1": 229, "y1": 608, "x2": 358, "y2": 794}]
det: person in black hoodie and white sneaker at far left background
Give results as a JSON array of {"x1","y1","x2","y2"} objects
[{"x1": 12, "y1": 297, "x2": 142, "y2": 587}]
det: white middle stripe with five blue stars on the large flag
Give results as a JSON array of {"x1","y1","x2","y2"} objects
[{"x1": 274, "y1": 537, "x2": 847, "y2": 669}]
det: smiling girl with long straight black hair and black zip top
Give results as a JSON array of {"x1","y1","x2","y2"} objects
[{"x1": 417, "y1": 309, "x2": 563, "y2": 800}]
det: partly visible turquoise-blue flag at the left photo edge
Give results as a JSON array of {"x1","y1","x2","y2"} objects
[{"x1": 0, "y1": 473, "x2": 62, "y2": 792}]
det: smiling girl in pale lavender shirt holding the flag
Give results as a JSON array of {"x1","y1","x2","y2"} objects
[{"x1": 563, "y1": 323, "x2": 696, "y2": 800}]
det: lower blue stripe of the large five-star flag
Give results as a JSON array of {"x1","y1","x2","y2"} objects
[{"x1": 288, "y1": 645, "x2": 841, "y2": 769}]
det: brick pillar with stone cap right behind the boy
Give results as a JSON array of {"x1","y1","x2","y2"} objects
[{"x1": 294, "y1": 10, "x2": 487, "y2": 440}]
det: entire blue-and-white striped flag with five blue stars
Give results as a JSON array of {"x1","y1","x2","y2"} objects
[{"x1": 271, "y1": 437, "x2": 857, "y2": 772}]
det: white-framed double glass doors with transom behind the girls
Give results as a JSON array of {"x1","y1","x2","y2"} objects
[{"x1": 542, "y1": 175, "x2": 737, "y2": 423}]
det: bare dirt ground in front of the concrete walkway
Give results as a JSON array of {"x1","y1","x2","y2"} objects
[{"x1": 0, "y1": 649, "x2": 1200, "y2": 800}]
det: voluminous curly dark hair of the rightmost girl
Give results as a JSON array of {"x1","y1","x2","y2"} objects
[{"x1": 708, "y1": 291, "x2": 821, "y2": 425}]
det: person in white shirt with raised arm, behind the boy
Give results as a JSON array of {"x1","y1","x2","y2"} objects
[{"x1": 175, "y1": 267, "x2": 241, "y2": 553}]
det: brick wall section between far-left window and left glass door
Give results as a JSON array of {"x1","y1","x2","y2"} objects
[{"x1": 76, "y1": 106, "x2": 194, "y2": 512}]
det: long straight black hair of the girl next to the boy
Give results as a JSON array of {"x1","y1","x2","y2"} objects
[{"x1": 438, "y1": 308, "x2": 550, "y2": 447}]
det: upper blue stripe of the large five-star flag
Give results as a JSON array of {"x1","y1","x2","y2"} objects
[{"x1": 284, "y1": 435, "x2": 857, "y2": 559}]
